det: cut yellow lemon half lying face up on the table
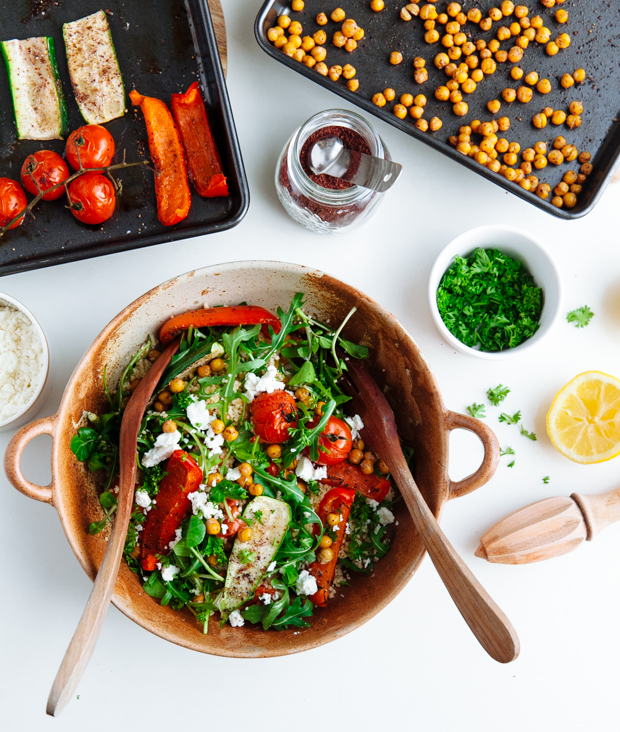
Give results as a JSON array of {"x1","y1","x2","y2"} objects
[{"x1": 547, "y1": 371, "x2": 620, "y2": 465}]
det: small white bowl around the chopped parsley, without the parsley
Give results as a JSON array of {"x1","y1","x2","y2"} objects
[{"x1": 428, "y1": 226, "x2": 562, "y2": 361}]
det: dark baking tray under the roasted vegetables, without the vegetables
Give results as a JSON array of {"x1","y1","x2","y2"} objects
[{"x1": 0, "y1": 0, "x2": 249, "y2": 274}]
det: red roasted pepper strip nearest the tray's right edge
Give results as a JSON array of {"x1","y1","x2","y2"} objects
[{"x1": 172, "y1": 81, "x2": 228, "y2": 198}]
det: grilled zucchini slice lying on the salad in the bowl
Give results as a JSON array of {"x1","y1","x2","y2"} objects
[{"x1": 218, "y1": 496, "x2": 291, "y2": 618}]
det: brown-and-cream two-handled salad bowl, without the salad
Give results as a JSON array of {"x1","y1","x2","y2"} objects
[{"x1": 5, "y1": 261, "x2": 499, "y2": 658}]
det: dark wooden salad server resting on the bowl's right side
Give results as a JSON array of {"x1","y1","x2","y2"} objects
[{"x1": 339, "y1": 358, "x2": 519, "y2": 663}]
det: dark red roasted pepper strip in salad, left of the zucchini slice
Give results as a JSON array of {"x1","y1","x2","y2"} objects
[{"x1": 140, "y1": 450, "x2": 202, "y2": 572}]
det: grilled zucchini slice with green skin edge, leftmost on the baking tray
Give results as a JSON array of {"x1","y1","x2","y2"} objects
[{"x1": 0, "y1": 36, "x2": 68, "y2": 140}]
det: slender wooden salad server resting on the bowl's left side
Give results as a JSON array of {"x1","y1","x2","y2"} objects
[{"x1": 47, "y1": 339, "x2": 180, "y2": 717}]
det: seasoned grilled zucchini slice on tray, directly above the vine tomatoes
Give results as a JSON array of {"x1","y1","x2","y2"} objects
[{"x1": 62, "y1": 10, "x2": 125, "y2": 125}]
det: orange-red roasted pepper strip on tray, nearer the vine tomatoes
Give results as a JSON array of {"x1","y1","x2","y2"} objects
[{"x1": 129, "y1": 90, "x2": 192, "y2": 226}]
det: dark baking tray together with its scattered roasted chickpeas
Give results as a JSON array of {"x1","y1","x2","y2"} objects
[{"x1": 255, "y1": 0, "x2": 620, "y2": 219}]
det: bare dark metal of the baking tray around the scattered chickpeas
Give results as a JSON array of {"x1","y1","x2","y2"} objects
[{"x1": 255, "y1": 0, "x2": 620, "y2": 220}]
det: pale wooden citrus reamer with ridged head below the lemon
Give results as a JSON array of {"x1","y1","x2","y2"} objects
[{"x1": 476, "y1": 488, "x2": 620, "y2": 564}]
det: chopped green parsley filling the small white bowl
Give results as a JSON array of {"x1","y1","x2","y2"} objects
[{"x1": 437, "y1": 249, "x2": 542, "y2": 351}]
